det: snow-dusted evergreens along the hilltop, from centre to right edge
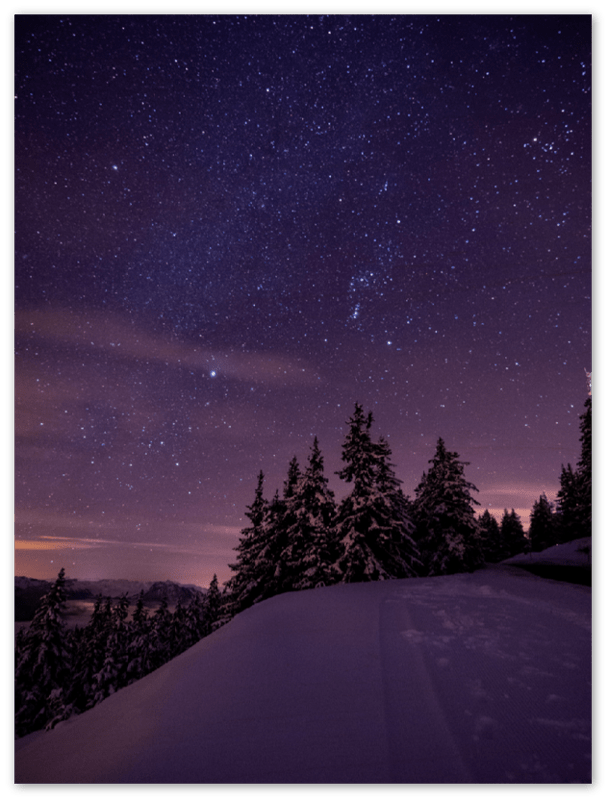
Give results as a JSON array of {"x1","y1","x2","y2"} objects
[{"x1": 222, "y1": 397, "x2": 591, "y2": 619}]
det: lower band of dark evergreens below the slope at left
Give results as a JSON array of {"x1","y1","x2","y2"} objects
[{"x1": 14, "y1": 568, "x2": 221, "y2": 737}]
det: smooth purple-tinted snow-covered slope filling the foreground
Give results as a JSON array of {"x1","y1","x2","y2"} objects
[{"x1": 15, "y1": 566, "x2": 591, "y2": 784}]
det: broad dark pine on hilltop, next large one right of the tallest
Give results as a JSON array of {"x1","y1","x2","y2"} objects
[{"x1": 414, "y1": 438, "x2": 483, "y2": 575}]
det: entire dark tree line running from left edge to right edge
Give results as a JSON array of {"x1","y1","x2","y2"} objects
[{"x1": 15, "y1": 397, "x2": 591, "y2": 736}]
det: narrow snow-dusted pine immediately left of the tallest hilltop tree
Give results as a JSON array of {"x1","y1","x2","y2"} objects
[{"x1": 283, "y1": 436, "x2": 336, "y2": 590}]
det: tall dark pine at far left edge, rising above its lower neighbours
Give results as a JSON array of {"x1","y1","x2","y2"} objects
[{"x1": 15, "y1": 568, "x2": 71, "y2": 736}]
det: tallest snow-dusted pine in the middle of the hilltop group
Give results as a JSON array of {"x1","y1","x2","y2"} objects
[{"x1": 334, "y1": 403, "x2": 417, "y2": 583}]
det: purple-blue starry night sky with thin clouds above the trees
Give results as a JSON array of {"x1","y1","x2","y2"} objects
[{"x1": 14, "y1": 12, "x2": 599, "y2": 586}]
